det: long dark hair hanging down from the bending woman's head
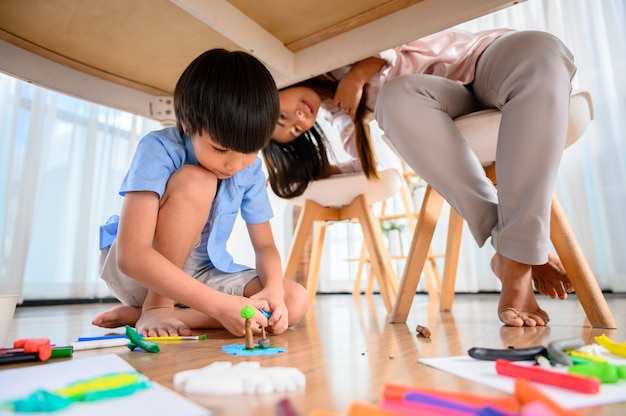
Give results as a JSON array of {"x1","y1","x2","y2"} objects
[{"x1": 263, "y1": 75, "x2": 378, "y2": 198}]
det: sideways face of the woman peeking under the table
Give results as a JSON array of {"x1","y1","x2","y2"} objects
[{"x1": 272, "y1": 87, "x2": 322, "y2": 143}]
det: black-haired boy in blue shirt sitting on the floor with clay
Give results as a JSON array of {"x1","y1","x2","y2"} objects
[{"x1": 93, "y1": 49, "x2": 308, "y2": 336}]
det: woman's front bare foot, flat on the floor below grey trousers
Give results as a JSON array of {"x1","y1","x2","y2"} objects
[{"x1": 491, "y1": 253, "x2": 550, "y2": 326}]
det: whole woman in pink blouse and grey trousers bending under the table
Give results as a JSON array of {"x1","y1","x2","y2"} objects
[{"x1": 264, "y1": 29, "x2": 576, "y2": 326}]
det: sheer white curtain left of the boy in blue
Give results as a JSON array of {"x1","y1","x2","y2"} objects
[{"x1": 0, "y1": 74, "x2": 158, "y2": 299}]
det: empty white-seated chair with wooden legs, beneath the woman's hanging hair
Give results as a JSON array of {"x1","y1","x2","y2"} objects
[{"x1": 285, "y1": 169, "x2": 403, "y2": 311}]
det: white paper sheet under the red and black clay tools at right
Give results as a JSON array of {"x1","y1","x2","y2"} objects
[{"x1": 419, "y1": 355, "x2": 626, "y2": 409}]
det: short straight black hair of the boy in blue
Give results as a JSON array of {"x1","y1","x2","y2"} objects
[{"x1": 174, "y1": 48, "x2": 280, "y2": 154}]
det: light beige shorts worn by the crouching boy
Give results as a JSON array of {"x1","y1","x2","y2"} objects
[{"x1": 99, "y1": 241, "x2": 257, "y2": 307}]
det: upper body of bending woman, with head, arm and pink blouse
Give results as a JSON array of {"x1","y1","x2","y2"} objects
[{"x1": 263, "y1": 29, "x2": 511, "y2": 198}]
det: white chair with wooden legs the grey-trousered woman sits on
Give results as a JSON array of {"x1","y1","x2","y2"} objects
[{"x1": 391, "y1": 91, "x2": 616, "y2": 328}]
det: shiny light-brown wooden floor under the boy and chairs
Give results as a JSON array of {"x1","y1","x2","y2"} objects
[{"x1": 0, "y1": 294, "x2": 626, "y2": 416}]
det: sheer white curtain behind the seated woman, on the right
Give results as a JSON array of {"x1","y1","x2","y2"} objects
[{"x1": 320, "y1": 0, "x2": 626, "y2": 292}]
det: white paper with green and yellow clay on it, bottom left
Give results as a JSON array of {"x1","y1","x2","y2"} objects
[{"x1": 0, "y1": 354, "x2": 211, "y2": 416}]
